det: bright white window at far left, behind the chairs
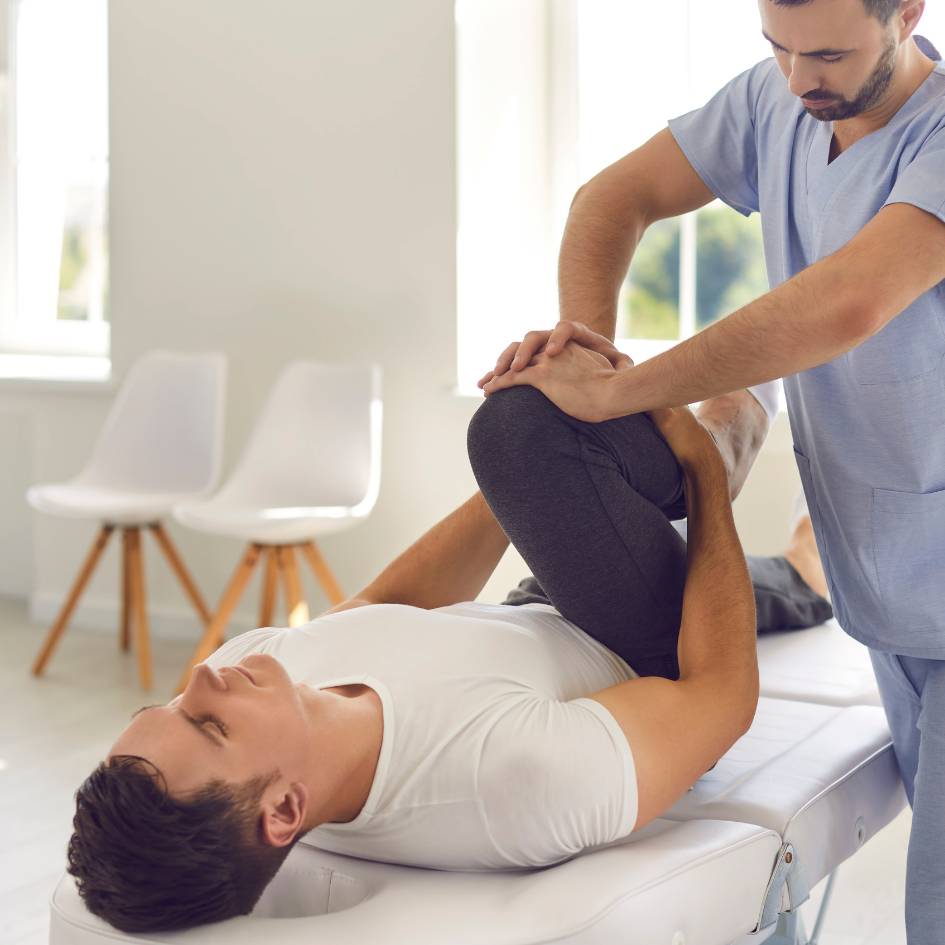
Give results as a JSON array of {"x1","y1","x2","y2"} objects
[{"x1": 0, "y1": 0, "x2": 109, "y2": 374}]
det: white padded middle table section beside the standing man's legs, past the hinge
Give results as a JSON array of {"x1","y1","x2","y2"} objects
[{"x1": 664, "y1": 697, "x2": 906, "y2": 888}]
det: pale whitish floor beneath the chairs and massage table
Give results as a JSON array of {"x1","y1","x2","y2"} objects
[{"x1": 0, "y1": 599, "x2": 910, "y2": 945}]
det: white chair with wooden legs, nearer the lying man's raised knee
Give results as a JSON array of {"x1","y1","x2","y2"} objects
[{"x1": 174, "y1": 361, "x2": 381, "y2": 688}]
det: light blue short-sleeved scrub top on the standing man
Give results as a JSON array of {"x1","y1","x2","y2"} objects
[{"x1": 669, "y1": 37, "x2": 945, "y2": 659}]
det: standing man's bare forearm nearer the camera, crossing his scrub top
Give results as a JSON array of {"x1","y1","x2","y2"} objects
[{"x1": 604, "y1": 258, "x2": 875, "y2": 417}]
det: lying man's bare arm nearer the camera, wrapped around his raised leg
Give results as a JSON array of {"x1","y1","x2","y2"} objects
[{"x1": 590, "y1": 408, "x2": 758, "y2": 827}]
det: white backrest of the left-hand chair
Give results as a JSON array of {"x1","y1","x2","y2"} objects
[{"x1": 73, "y1": 351, "x2": 226, "y2": 495}]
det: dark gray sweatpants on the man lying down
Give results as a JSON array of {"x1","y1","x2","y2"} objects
[{"x1": 467, "y1": 386, "x2": 833, "y2": 679}]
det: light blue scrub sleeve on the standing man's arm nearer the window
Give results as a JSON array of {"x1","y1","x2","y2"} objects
[{"x1": 669, "y1": 60, "x2": 771, "y2": 217}]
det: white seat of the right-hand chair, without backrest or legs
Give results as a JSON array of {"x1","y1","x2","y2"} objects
[{"x1": 174, "y1": 500, "x2": 367, "y2": 545}]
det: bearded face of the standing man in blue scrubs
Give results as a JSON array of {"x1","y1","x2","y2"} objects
[{"x1": 759, "y1": 0, "x2": 899, "y2": 121}]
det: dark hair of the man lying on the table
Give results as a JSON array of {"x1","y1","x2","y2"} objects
[{"x1": 68, "y1": 755, "x2": 298, "y2": 932}]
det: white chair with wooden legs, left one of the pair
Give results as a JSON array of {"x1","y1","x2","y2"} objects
[{"x1": 27, "y1": 351, "x2": 226, "y2": 689}]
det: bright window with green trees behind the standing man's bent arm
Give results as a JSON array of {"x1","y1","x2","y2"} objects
[{"x1": 576, "y1": 0, "x2": 771, "y2": 359}]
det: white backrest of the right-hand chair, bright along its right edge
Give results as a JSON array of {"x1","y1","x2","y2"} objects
[{"x1": 214, "y1": 361, "x2": 382, "y2": 515}]
